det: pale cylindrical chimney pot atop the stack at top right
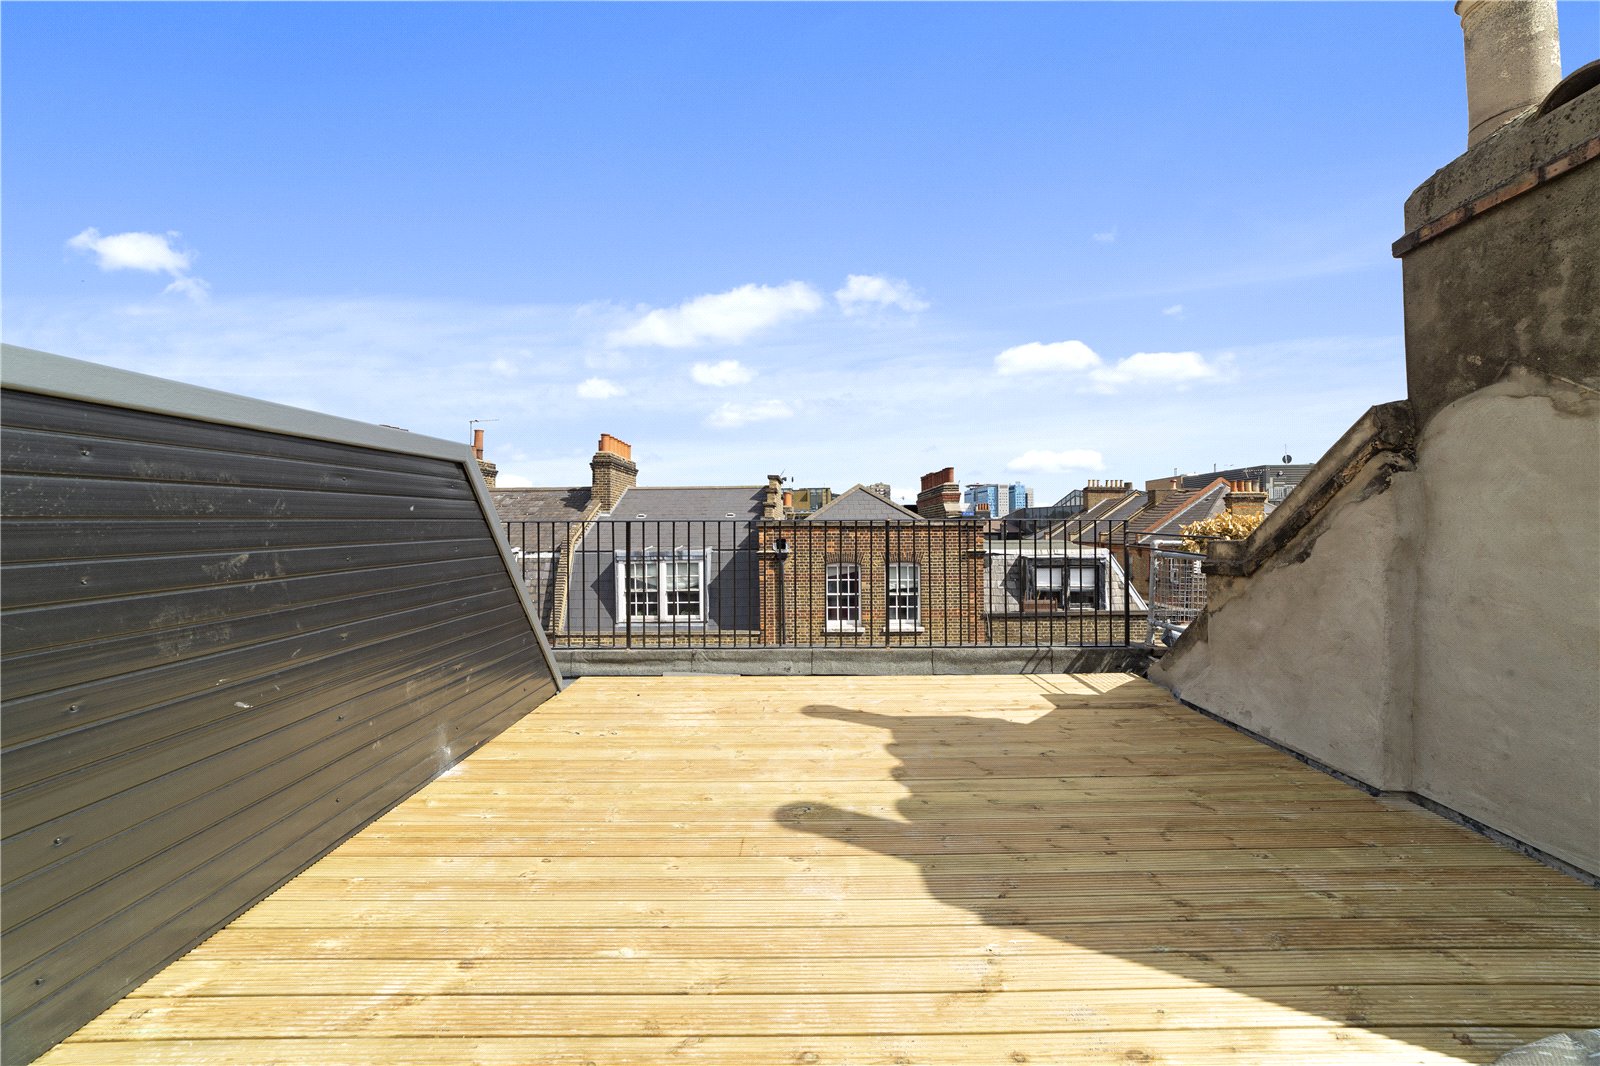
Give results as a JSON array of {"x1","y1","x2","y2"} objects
[{"x1": 1456, "y1": 0, "x2": 1562, "y2": 147}]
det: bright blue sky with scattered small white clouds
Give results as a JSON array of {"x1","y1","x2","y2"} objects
[{"x1": 0, "y1": 0, "x2": 1600, "y2": 499}]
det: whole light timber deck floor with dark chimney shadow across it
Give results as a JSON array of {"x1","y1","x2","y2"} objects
[{"x1": 40, "y1": 675, "x2": 1600, "y2": 1066}]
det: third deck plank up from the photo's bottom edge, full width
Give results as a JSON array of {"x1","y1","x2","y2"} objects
[{"x1": 136, "y1": 946, "x2": 1600, "y2": 999}]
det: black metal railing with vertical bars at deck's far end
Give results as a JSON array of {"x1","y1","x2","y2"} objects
[{"x1": 506, "y1": 519, "x2": 1147, "y2": 648}]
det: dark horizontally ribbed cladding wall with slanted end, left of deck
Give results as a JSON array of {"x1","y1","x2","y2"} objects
[{"x1": 0, "y1": 349, "x2": 560, "y2": 1063}]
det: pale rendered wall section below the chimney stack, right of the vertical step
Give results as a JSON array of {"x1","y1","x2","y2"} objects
[{"x1": 1411, "y1": 373, "x2": 1600, "y2": 872}]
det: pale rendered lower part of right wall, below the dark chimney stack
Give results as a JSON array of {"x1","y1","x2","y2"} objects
[{"x1": 1150, "y1": 370, "x2": 1600, "y2": 872}]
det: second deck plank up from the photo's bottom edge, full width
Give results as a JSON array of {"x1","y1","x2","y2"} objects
[{"x1": 65, "y1": 984, "x2": 1597, "y2": 1040}]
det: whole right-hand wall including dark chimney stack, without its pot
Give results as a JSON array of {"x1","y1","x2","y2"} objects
[{"x1": 1150, "y1": 80, "x2": 1600, "y2": 874}]
